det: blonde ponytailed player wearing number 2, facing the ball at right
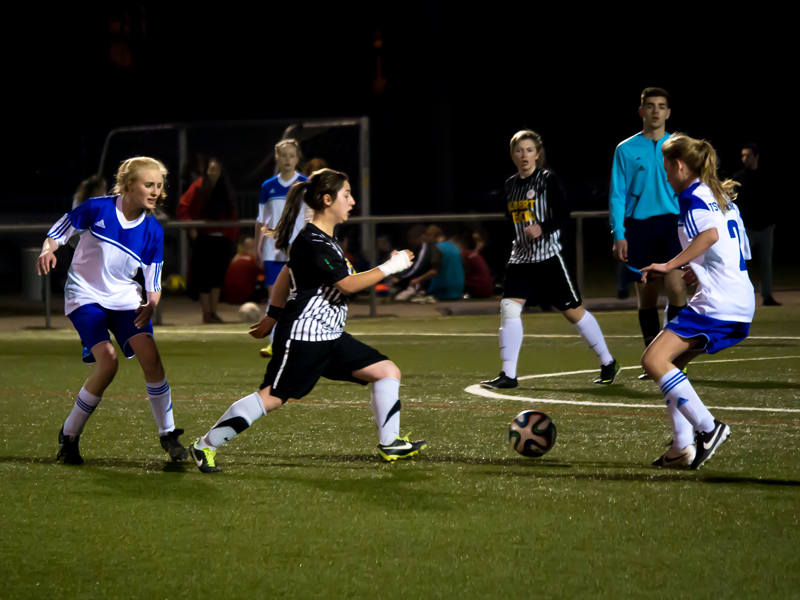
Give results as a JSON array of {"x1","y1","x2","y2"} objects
[{"x1": 642, "y1": 134, "x2": 755, "y2": 469}]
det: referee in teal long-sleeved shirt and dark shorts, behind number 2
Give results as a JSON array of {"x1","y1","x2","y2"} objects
[{"x1": 608, "y1": 88, "x2": 686, "y2": 378}]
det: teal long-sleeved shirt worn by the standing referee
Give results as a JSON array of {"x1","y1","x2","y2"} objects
[{"x1": 608, "y1": 133, "x2": 679, "y2": 242}]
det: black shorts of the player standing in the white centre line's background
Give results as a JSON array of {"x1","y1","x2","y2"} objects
[{"x1": 503, "y1": 254, "x2": 581, "y2": 311}]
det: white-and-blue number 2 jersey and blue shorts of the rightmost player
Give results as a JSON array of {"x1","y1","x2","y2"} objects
[{"x1": 667, "y1": 179, "x2": 756, "y2": 354}]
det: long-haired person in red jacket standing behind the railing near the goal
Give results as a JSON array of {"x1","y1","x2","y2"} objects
[{"x1": 178, "y1": 158, "x2": 239, "y2": 323}]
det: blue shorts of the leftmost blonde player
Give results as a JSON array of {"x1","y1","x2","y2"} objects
[{"x1": 67, "y1": 304, "x2": 153, "y2": 364}]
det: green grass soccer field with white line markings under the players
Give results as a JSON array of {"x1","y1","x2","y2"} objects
[{"x1": 0, "y1": 307, "x2": 800, "y2": 600}]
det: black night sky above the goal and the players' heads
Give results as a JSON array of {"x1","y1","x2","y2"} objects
[{"x1": 2, "y1": 2, "x2": 796, "y2": 223}]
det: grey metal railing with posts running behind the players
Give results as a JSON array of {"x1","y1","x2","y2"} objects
[{"x1": 0, "y1": 210, "x2": 608, "y2": 328}]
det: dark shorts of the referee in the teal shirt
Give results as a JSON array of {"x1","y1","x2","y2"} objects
[{"x1": 625, "y1": 215, "x2": 681, "y2": 281}]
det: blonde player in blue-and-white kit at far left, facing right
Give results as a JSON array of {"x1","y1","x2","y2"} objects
[{"x1": 37, "y1": 157, "x2": 188, "y2": 465}]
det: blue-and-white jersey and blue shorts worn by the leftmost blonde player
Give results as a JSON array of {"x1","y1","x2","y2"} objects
[{"x1": 47, "y1": 196, "x2": 164, "y2": 362}]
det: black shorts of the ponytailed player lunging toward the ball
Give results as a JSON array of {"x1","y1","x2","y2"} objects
[{"x1": 260, "y1": 331, "x2": 389, "y2": 402}]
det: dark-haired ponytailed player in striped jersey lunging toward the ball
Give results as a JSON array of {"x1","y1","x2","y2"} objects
[{"x1": 189, "y1": 169, "x2": 428, "y2": 473}]
